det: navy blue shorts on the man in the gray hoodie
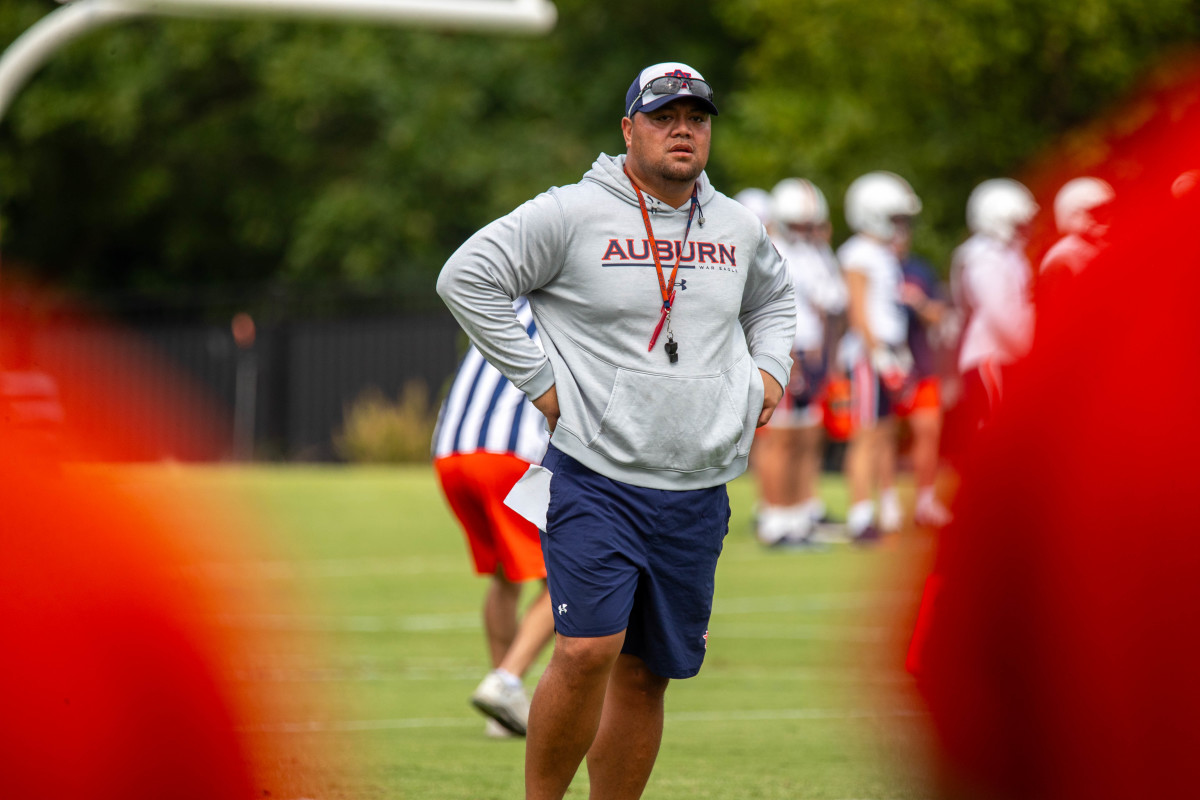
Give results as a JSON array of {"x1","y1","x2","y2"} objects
[{"x1": 541, "y1": 446, "x2": 730, "y2": 678}]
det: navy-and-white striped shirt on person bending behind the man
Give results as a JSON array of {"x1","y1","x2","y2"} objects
[{"x1": 433, "y1": 297, "x2": 550, "y2": 464}]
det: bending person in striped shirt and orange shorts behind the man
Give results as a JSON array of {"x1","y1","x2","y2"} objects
[{"x1": 433, "y1": 297, "x2": 554, "y2": 738}]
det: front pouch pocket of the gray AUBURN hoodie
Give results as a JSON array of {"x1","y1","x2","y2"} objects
[{"x1": 589, "y1": 357, "x2": 762, "y2": 473}]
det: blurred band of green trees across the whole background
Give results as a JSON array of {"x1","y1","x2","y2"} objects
[{"x1": 0, "y1": 0, "x2": 1198, "y2": 306}]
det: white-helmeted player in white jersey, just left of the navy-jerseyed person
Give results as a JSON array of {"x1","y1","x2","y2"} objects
[{"x1": 838, "y1": 172, "x2": 922, "y2": 545}]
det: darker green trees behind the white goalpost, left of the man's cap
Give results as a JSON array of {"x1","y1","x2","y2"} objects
[{"x1": 0, "y1": 0, "x2": 736, "y2": 316}]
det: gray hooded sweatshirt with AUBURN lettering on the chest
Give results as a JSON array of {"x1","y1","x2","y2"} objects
[{"x1": 438, "y1": 154, "x2": 796, "y2": 489}]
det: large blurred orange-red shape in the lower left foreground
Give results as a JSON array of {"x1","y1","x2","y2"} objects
[{"x1": 0, "y1": 293, "x2": 295, "y2": 800}]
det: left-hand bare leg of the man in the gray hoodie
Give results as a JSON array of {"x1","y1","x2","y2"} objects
[{"x1": 526, "y1": 631, "x2": 625, "y2": 800}]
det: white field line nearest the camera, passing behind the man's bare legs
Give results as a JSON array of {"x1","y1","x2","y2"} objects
[{"x1": 241, "y1": 709, "x2": 924, "y2": 733}]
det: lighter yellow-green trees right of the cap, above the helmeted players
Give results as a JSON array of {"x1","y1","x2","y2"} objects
[{"x1": 719, "y1": 0, "x2": 1200, "y2": 265}]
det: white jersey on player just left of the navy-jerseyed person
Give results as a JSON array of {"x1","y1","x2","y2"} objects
[{"x1": 838, "y1": 234, "x2": 908, "y2": 366}]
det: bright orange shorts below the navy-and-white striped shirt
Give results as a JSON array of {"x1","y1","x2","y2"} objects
[{"x1": 433, "y1": 452, "x2": 546, "y2": 582}]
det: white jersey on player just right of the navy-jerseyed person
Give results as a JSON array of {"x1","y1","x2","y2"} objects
[{"x1": 953, "y1": 234, "x2": 1033, "y2": 372}]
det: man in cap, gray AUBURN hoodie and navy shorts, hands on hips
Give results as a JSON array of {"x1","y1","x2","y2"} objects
[{"x1": 438, "y1": 62, "x2": 794, "y2": 800}]
